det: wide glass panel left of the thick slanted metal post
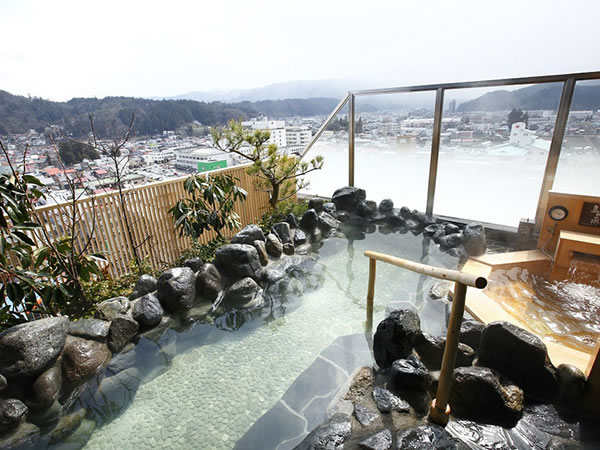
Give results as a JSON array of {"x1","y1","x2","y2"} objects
[{"x1": 434, "y1": 83, "x2": 562, "y2": 227}]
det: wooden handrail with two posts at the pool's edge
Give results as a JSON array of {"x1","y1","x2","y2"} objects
[{"x1": 365, "y1": 250, "x2": 487, "y2": 426}]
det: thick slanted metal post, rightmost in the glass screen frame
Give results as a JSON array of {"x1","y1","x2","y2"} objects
[{"x1": 534, "y1": 78, "x2": 575, "y2": 233}]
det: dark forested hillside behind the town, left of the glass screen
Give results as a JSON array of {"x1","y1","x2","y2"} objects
[{"x1": 0, "y1": 91, "x2": 338, "y2": 138}]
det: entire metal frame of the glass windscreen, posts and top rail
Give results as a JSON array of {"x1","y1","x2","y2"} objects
[{"x1": 301, "y1": 72, "x2": 600, "y2": 234}]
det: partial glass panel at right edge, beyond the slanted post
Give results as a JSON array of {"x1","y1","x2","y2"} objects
[{"x1": 552, "y1": 81, "x2": 600, "y2": 195}]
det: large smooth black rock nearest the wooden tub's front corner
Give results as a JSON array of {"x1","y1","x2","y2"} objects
[{"x1": 478, "y1": 322, "x2": 558, "y2": 400}]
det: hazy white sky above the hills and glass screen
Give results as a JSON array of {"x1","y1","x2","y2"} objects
[{"x1": 0, "y1": 0, "x2": 600, "y2": 100}]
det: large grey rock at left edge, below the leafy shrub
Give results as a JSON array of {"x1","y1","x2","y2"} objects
[{"x1": 0, "y1": 317, "x2": 69, "y2": 379}]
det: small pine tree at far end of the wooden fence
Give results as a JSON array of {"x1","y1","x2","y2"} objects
[{"x1": 212, "y1": 120, "x2": 323, "y2": 208}]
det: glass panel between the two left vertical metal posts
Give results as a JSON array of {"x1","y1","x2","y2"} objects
[{"x1": 354, "y1": 92, "x2": 435, "y2": 211}]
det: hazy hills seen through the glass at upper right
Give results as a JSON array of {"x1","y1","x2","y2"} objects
[{"x1": 457, "y1": 83, "x2": 600, "y2": 112}]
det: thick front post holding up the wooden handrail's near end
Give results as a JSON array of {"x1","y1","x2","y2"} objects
[{"x1": 429, "y1": 281, "x2": 467, "y2": 426}]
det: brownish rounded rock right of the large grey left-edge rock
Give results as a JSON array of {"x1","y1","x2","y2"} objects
[{"x1": 62, "y1": 338, "x2": 112, "y2": 383}]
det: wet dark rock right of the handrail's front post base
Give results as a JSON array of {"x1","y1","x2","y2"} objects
[{"x1": 449, "y1": 366, "x2": 523, "y2": 427}]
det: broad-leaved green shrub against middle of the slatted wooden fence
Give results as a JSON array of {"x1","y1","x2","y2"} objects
[{"x1": 169, "y1": 173, "x2": 248, "y2": 240}]
